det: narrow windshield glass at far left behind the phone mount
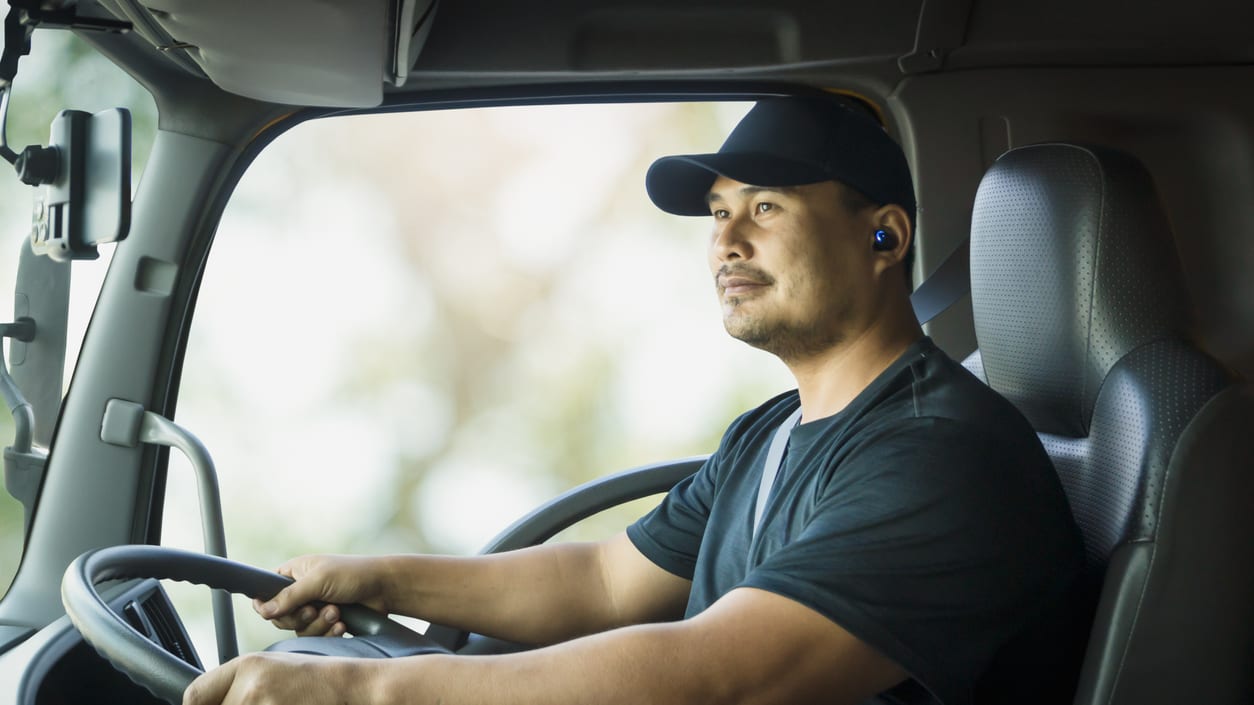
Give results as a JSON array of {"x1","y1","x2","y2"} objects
[{"x1": 0, "y1": 30, "x2": 157, "y2": 593}]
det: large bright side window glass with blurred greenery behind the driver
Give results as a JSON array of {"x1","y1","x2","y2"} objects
[{"x1": 163, "y1": 104, "x2": 791, "y2": 661}]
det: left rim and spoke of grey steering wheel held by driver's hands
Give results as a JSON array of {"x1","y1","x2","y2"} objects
[{"x1": 61, "y1": 546, "x2": 448, "y2": 702}]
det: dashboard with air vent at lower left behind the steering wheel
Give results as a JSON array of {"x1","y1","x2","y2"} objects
[{"x1": 0, "y1": 580, "x2": 203, "y2": 705}]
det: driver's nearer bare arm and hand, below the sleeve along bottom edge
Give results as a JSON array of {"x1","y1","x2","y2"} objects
[{"x1": 184, "y1": 588, "x2": 907, "y2": 705}]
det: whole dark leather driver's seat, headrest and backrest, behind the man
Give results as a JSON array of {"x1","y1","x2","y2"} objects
[{"x1": 966, "y1": 144, "x2": 1254, "y2": 705}]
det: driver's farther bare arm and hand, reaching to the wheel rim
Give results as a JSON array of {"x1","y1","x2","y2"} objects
[{"x1": 258, "y1": 533, "x2": 691, "y2": 645}]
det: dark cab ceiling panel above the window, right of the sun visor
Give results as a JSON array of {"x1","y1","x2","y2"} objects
[{"x1": 411, "y1": 0, "x2": 1254, "y2": 78}]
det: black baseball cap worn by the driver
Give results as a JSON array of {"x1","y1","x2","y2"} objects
[{"x1": 645, "y1": 98, "x2": 915, "y2": 221}]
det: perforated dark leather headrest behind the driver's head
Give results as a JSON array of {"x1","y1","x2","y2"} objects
[{"x1": 971, "y1": 144, "x2": 1188, "y2": 438}]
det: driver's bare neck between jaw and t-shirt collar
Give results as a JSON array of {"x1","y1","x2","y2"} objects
[{"x1": 786, "y1": 314, "x2": 923, "y2": 423}]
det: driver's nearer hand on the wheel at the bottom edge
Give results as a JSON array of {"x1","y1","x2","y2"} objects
[{"x1": 183, "y1": 654, "x2": 372, "y2": 705}]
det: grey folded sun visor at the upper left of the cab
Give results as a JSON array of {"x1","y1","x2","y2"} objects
[{"x1": 113, "y1": 0, "x2": 436, "y2": 108}]
